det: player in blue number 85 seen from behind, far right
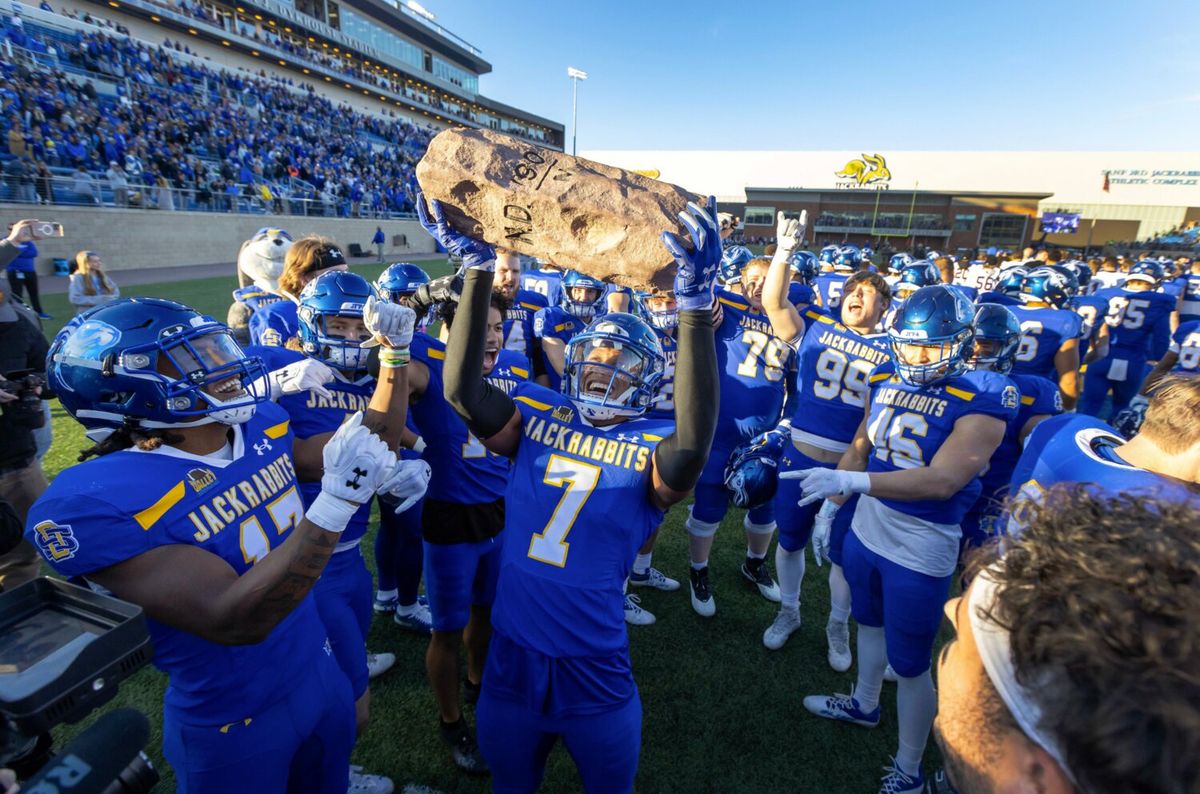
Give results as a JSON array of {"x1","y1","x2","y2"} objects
[{"x1": 1079, "y1": 259, "x2": 1176, "y2": 416}]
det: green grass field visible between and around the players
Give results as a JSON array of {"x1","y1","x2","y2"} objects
[{"x1": 39, "y1": 263, "x2": 936, "y2": 794}]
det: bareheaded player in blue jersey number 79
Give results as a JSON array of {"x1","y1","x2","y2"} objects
[{"x1": 676, "y1": 258, "x2": 796, "y2": 618}]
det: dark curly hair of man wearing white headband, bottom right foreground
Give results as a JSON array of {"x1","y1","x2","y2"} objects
[{"x1": 967, "y1": 483, "x2": 1200, "y2": 794}]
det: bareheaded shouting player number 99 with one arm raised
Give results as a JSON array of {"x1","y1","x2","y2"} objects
[{"x1": 757, "y1": 213, "x2": 890, "y2": 673}]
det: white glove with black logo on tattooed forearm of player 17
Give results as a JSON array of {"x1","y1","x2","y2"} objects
[{"x1": 305, "y1": 411, "x2": 396, "y2": 533}]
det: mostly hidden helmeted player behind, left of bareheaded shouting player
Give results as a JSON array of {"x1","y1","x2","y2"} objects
[{"x1": 373, "y1": 261, "x2": 433, "y2": 636}]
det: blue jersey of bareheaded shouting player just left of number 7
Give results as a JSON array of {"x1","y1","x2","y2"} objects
[{"x1": 409, "y1": 333, "x2": 529, "y2": 505}]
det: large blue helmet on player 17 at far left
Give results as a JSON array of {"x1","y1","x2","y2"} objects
[{"x1": 46, "y1": 297, "x2": 270, "y2": 440}]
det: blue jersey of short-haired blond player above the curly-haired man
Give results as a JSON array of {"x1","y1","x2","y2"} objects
[{"x1": 1008, "y1": 414, "x2": 1198, "y2": 533}]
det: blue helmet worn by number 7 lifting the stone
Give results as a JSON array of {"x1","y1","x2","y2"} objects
[{"x1": 562, "y1": 312, "x2": 666, "y2": 420}]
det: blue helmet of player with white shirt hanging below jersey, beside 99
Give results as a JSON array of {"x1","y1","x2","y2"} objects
[{"x1": 888, "y1": 284, "x2": 974, "y2": 386}]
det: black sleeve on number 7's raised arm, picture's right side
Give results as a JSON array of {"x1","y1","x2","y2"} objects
[{"x1": 654, "y1": 309, "x2": 721, "y2": 492}]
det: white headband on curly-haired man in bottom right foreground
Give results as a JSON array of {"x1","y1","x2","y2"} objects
[{"x1": 967, "y1": 563, "x2": 1075, "y2": 783}]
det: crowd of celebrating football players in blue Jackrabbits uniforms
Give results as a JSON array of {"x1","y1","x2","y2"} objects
[{"x1": 26, "y1": 199, "x2": 1200, "y2": 794}]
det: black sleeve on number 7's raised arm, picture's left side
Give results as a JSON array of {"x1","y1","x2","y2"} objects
[{"x1": 442, "y1": 270, "x2": 517, "y2": 439}]
